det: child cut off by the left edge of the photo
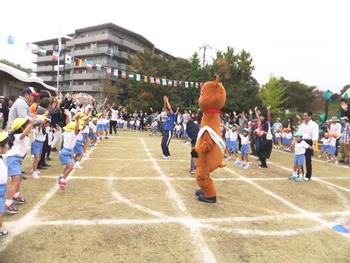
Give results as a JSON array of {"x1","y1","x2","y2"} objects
[{"x1": 0, "y1": 132, "x2": 9, "y2": 237}]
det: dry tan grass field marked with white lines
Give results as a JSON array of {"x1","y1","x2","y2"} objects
[{"x1": 0, "y1": 132, "x2": 350, "y2": 263}]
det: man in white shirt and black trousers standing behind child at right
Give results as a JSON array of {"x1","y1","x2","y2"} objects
[{"x1": 298, "y1": 112, "x2": 319, "y2": 181}]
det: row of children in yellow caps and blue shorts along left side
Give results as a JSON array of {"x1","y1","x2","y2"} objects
[{"x1": 0, "y1": 104, "x2": 113, "y2": 237}]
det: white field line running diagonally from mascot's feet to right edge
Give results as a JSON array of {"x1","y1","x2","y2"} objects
[{"x1": 224, "y1": 167, "x2": 350, "y2": 239}]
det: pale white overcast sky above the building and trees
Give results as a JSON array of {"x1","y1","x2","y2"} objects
[{"x1": 0, "y1": 0, "x2": 350, "y2": 91}]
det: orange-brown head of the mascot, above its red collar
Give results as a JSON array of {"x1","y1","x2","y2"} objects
[{"x1": 198, "y1": 76, "x2": 226, "y2": 112}]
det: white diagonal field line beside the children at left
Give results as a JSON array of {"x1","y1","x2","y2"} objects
[{"x1": 0, "y1": 148, "x2": 95, "y2": 252}]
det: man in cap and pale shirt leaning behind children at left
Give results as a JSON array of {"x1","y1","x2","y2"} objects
[{"x1": 7, "y1": 87, "x2": 39, "y2": 130}]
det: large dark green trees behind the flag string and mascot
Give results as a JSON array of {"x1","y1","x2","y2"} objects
[{"x1": 106, "y1": 47, "x2": 261, "y2": 111}]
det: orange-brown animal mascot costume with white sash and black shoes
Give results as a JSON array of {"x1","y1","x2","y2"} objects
[{"x1": 192, "y1": 76, "x2": 226, "y2": 203}]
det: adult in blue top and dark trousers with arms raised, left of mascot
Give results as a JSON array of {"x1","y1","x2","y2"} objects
[{"x1": 161, "y1": 96, "x2": 176, "y2": 160}]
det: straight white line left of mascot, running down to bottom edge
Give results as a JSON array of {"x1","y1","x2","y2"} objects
[{"x1": 140, "y1": 138, "x2": 216, "y2": 263}]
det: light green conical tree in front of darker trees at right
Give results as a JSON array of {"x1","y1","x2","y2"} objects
[{"x1": 260, "y1": 77, "x2": 287, "y2": 113}]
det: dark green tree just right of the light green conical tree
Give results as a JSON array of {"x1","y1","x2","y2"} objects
[{"x1": 280, "y1": 77, "x2": 316, "y2": 112}]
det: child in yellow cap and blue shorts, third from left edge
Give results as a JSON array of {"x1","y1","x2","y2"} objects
[{"x1": 31, "y1": 115, "x2": 47, "y2": 179}]
